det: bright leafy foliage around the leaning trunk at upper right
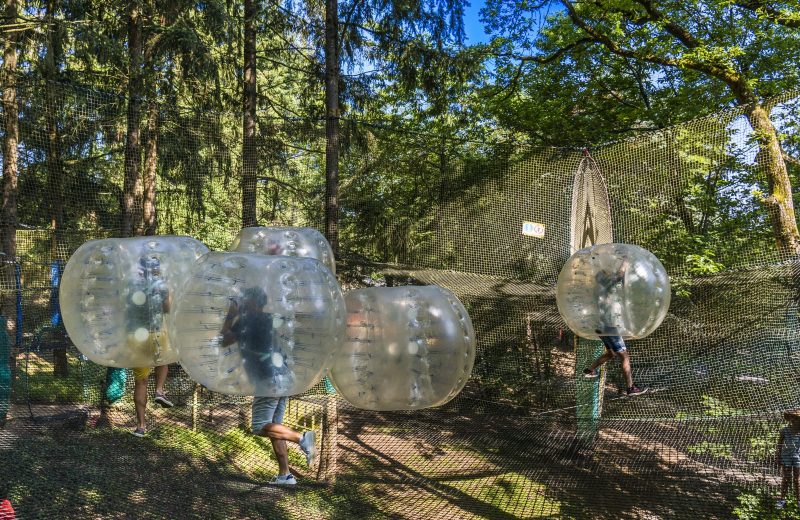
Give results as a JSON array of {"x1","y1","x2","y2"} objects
[{"x1": 481, "y1": 0, "x2": 800, "y2": 260}]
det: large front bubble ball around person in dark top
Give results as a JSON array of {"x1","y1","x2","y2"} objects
[{"x1": 170, "y1": 252, "x2": 345, "y2": 397}]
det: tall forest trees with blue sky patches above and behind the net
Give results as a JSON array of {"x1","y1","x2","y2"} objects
[{"x1": 0, "y1": 0, "x2": 800, "y2": 273}]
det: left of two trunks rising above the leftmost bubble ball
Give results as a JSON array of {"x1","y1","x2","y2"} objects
[{"x1": 122, "y1": 0, "x2": 143, "y2": 237}]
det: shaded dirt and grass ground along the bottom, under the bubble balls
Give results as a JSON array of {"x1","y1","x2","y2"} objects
[{"x1": 0, "y1": 405, "x2": 776, "y2": 519}]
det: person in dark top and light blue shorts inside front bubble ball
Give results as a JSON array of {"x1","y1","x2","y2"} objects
[{"x1": 222, "y1": 287, "x2": 316, "y2": 485}]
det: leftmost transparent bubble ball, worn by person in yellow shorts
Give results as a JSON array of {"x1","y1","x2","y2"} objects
[{"x1": 59, "y1": 236, "x2": 208, "y2": 368}]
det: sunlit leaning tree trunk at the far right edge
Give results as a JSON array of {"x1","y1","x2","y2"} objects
[{"x1": 747, "y1": 103, "x2": 800, "y2": 258}]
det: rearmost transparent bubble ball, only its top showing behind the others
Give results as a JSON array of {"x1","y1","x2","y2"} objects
[{"x1": 230, "y1": 227, "x2": 336, "y2": 274}]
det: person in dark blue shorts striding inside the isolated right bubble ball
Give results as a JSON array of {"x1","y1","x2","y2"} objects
[{"x1": 583, "y1": 258, "x2": 648, "y2": 396}]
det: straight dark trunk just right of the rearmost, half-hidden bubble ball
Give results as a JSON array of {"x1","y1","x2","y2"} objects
[{"x1": 325, "y1": 0, "x2": 339, "y2": 256}]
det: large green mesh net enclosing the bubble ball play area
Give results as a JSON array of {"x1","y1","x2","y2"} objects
[{"x1": 0, "y1": 78, "x2": 800, "y2": 519}]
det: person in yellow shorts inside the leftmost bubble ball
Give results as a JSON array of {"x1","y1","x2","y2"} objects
[{"x1": 128, "y1": 255, "x2": 173, "y2": 437}]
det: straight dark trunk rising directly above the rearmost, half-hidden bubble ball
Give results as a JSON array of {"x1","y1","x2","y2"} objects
[{"x1": 242, "y1": 0, "x2": 258, "y2": 227}]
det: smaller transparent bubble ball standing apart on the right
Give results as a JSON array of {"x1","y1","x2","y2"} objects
[{"x1": 556, "y1": 244, "x2": 670, "y2": 339}]
